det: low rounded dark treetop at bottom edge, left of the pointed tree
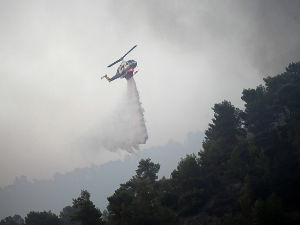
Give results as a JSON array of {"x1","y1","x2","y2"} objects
[{"x1": 25, "y1": 211, "x2": 60, "y2": 225}]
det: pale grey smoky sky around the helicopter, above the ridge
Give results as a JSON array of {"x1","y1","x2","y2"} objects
[{"x1": 0, "y1": 0, "x2": 300, "y2": 186}]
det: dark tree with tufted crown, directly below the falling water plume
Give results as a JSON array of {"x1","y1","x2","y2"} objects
[{"x1": 107, "y1": 159, "x2": 175, "y2": 225}]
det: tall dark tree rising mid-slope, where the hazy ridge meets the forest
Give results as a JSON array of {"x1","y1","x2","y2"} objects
[{"x1": 198, "y1": 101, "x2": 246, "y2": 185}]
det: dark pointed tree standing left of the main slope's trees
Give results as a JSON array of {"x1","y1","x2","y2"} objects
[{"x1": 71, "y1": 190, "x2": 105, "y2": 225}]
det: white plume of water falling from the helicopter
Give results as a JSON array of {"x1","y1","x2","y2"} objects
[{"x1": 80, "y1": 78, "x2": 148, "y2": 153}]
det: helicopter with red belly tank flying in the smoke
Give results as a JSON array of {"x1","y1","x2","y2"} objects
[{"x1": 101, "y1": 45, "x2": 138, "y2": 82}]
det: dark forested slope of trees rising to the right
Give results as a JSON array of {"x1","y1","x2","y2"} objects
[{"x1": 0, "y1": 62, "x2": 300, "y2": 225}]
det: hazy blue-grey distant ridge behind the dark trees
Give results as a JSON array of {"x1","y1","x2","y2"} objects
[{"x1": 0, "y1": 131, "x2": 204, "y2": 219}]
